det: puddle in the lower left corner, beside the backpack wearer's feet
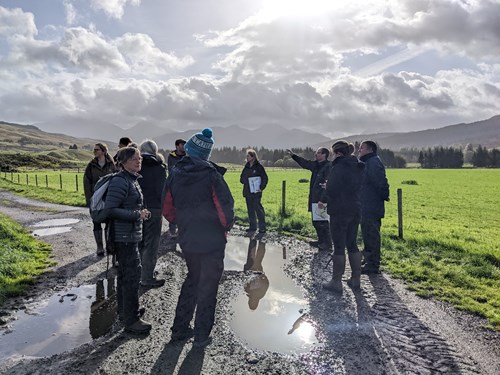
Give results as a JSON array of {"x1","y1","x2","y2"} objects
[{"x1": 0, "y1": 278, "x2": 116, "y2": 360}]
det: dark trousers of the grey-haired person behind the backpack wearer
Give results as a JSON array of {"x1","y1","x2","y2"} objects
[{"x1": 139, "y1": 209, "x2": 162, "y2": 284}]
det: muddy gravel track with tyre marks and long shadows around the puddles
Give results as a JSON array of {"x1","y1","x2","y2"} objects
[{"x1": 0, "y1": 192, "x2": 500, "y2": 375}]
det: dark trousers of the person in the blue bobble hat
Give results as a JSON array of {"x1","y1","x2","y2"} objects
[{"x1": 172, "y1": 249, "x2": 224, "y2": 340}]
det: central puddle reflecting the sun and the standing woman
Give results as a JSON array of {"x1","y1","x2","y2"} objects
[{"x1": 224, "y1": 237, "x2": 319, "y2": 354}]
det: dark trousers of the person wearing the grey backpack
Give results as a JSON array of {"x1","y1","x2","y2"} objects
[{"x1": 115, "y1": 242, "x2": 141, "y2": 326}]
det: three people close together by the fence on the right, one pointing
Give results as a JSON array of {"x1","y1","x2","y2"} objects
[{"x1": 287, "y1": 140, "x2": 389, "y2": 293}]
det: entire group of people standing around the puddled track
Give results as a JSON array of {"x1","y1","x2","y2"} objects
[{"x1": 84, "y1": 128, "x2": 389, "y2": 347}]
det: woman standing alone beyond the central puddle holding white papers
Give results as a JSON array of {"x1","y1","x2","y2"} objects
[{"x1": 240, "y1": 149, "x2": 268, "y2": 239}]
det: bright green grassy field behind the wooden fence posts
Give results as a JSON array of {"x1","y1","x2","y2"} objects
[{"x1": 0, "y1": 168, "x2": 500, "y2": 330}]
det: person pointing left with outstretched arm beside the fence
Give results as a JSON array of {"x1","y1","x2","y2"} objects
[{"x1": 286, "y1": 147, "x2": 332, "y2": 251}]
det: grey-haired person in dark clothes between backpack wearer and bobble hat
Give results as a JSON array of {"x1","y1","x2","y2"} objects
[{"x1": 139, "y1": 139, "x2": 167, "y2": 288}]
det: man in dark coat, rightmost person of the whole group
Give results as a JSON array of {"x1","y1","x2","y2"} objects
[{"x1": 358, "y1": 141, "x2": 389, "y2": 274}]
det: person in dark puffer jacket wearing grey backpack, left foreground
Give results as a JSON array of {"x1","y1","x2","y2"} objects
[{"x1": 104, "y1": 147, "x2": 151, "y2": 333}]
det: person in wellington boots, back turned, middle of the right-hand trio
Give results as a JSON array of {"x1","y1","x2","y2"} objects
[{"x1": 321, "y1": 141, "x2": 364, "y2": 293}]
